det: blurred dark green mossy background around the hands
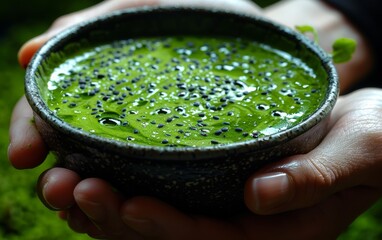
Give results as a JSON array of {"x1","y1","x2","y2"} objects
[{"x1": 0, "y1": 0, "x2": 382, "y2": 240}]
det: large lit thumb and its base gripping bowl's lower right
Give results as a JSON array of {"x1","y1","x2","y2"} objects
[{"x1": 245, "y1": 89, "x2": 382, "y2": 214}]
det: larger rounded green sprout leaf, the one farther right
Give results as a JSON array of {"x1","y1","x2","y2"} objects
[{"x1": 332, "y1": 38, "x2": 357, "y2": 63}]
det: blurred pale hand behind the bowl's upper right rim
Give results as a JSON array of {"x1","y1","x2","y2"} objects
[{"x1": 263, "y1": 0, "x2": 373, "y2": 92}]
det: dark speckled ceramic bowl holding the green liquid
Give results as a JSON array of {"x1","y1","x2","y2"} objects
[{"x1": 26, "y1": 8, "x2": 338, "y2": 215}]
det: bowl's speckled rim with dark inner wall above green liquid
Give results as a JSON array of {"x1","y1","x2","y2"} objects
[{"x1": 26, "y1": 8, "x2": 338, "y2": 159}]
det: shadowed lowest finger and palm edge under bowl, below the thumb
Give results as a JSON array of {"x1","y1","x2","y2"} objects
[{"x1": 121, "y1": 187, "x2": 380, "y2": 240}]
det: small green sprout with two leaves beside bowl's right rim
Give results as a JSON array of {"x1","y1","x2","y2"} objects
[{"x1": 296, "y1": 25, "x2": 357, "y2": 63}]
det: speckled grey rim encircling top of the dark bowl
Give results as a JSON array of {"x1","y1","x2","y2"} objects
[{"x1": 24, "y1": 6, "x2": 339, "y2": 161}]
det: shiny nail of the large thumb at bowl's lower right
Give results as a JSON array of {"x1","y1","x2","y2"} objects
[{"x1": 253, "y1": 173, "x2": 294, "y2": 213}]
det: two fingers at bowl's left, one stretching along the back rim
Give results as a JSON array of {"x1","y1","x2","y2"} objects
[{"x1": 8, "y1": 0, "x2": 261, "y2": 165}]
